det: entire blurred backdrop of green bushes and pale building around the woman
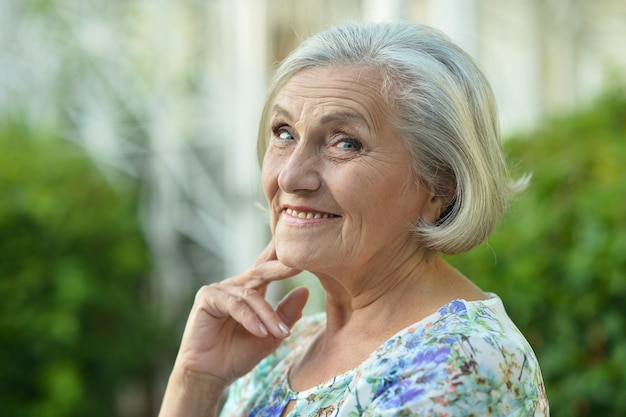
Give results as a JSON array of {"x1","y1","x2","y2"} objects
[{"x1": 0, "y1": 0, "x2": 626, "y2": 417}]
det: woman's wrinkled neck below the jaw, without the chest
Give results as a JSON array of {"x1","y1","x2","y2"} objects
[{"x1": 319, "y1": 253, "x2": 487, "y2": 341}]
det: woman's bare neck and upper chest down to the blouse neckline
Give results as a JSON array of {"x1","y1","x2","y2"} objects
[{"x1": 289, "y1": 247, "x2": 487, "y2": 391}]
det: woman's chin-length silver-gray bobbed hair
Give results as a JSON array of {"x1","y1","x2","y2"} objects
[{"x1": 257, "y1": 23, "x2": 527, "y2": 254}]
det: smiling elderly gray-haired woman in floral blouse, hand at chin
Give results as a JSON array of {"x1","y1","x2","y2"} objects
[{"x1": 161, "y1": 23, "x2": 548, "y2": 416}]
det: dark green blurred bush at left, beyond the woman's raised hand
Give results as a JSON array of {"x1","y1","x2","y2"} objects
[{"x1": 0, "y1": 122, "x2": 162, "y2": 417}]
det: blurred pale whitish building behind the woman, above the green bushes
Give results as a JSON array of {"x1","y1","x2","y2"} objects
[{"x1": 0, "y1": 0, "x2": 626, "y2": 317}]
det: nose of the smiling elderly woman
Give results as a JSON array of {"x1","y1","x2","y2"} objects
[{"x1": 278, "y1": 142, "x2": 322, "y2": 194}]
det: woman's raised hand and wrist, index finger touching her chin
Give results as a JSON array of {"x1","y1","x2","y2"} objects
[{"x1": 161, "y1": 242, "x2": 308, "y2": 416}]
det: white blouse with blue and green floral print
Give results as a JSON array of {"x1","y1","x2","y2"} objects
[{"x1": 220, "y1": 294, "x2": 549, "y2": 417}]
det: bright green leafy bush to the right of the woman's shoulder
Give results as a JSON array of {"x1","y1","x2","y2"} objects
[{"x1": 450, "y1": 88, "x2": 626, "y2": 417}]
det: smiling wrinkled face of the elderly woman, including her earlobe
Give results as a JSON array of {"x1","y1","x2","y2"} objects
[{"x1": 262, "y1": 67, "x2": 439, "y2": 274}]
